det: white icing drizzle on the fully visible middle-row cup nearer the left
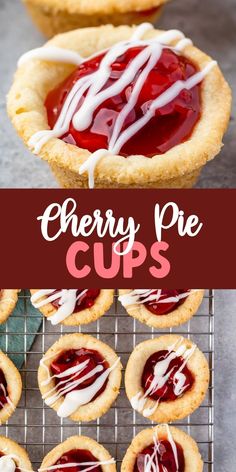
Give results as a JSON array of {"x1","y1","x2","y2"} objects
[{"x1": 40, "y1": 353, "x2": 120, "y2": 418}]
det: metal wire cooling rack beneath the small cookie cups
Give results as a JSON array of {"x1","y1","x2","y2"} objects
[{"x1": 0, "y1": 290, "x2": 214, "y2": 472}]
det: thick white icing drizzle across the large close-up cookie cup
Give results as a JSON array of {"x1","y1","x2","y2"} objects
[{"x1": 19, "y1": 23, "x2": 216, "y2": 188}]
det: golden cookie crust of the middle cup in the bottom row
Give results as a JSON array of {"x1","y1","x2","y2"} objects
[{"x1": 39, "y1": 436, "x2": 116, "y2": 472}]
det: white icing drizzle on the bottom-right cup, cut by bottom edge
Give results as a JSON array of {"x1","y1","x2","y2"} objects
[{"x1": 136, "y1": 424, "x2": 179, "y2": 472}]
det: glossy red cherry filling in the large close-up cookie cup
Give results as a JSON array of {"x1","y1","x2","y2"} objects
[{"x1": 45, "y1": 46, "x2": 201, "y2": 157}]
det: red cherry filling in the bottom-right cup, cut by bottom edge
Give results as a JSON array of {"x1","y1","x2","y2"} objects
[{"x1": 133, "y1": 439, "x2": 185, "y2": 472}]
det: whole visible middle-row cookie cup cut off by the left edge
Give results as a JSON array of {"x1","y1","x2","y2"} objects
[{"x1": 0, "y1": 351, "x2": 22, "y2": 425}]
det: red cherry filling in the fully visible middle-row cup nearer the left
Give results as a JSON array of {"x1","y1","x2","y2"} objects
[{"x1": 51, "y1": 348, "x2": 109, "y2": 401}]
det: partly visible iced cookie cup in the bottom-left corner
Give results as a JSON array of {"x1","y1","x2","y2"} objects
[{"x1": 0, "y1": 436, "x2": 33, "y2": 472}]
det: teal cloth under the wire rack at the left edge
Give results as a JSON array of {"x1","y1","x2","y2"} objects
[{"x1": 0, "y1": 290, "x2": 42, "y2": 369}]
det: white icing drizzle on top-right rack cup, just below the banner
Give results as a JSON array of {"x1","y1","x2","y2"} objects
[{"x1": 119, "y1": 288, "x2": 195, "y2": 307}]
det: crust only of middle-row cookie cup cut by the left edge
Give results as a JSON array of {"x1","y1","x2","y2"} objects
[{"x1": 0, "y1": 351, "x2": 22, "y2": 424}]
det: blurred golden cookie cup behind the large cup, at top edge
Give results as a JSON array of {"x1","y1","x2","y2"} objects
[{"x1": 23, "y1": 0, "x2": 167, "y2": 38}]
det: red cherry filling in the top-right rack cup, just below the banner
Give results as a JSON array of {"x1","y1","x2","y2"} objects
[{"x1": 140, "y1": 288, "x2": 190, "y2": 316}]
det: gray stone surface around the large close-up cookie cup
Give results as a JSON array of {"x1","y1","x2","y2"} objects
[{"x1": 0, "y1": 0, "x2": 236, "y2": 188}]
